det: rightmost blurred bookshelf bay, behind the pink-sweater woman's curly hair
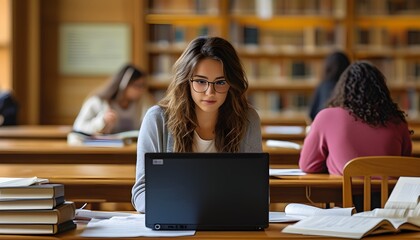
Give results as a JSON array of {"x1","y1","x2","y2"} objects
[{"x1": 352, "y1": 0, "x2": 420, "y2": 120}]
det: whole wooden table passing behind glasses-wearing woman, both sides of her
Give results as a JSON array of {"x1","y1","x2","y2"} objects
[{"x1": 0, "y1": 139, "x2": 420, "y2": 168}]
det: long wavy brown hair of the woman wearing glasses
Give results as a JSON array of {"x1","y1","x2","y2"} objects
[{"x1": 159, "y1": 37, "x2": 250, "y2": 152}]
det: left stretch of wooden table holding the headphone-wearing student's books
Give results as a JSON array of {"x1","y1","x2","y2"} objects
[{"x1": 0, "y1": 139, "x2": 137, "y2": 165}]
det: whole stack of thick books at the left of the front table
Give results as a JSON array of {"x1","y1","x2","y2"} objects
[{"x1": 0, "y1": 183, "x2": 76, "y2": 234}]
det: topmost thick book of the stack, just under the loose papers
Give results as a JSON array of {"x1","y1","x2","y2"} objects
[{"x1": 0, "y1": 183, "x2": 64, "y2": 200}]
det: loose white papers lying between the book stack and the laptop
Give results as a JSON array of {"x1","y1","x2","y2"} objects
[{"x1": 81, "y1": 214, "x2": 195, "y2": 238}]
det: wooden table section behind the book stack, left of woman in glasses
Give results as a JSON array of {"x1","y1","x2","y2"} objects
[{"x1": 0, "y1": 163, "x2": 136, "y2": 202}]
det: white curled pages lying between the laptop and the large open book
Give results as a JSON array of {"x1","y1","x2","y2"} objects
[{"x1": 269, "y1": 203, "x2": 354, "y2": 222}]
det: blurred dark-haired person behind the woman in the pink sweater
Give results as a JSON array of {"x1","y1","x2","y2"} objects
[{"x1": 309, "y1": 52, "x2": 350, "y2": 121}]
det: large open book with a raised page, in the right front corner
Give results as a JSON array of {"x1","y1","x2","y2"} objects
[{"x1": 283, "y1": 177, "x2": 420, "y2": 239}]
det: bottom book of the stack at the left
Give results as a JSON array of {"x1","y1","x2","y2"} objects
[{"x1": 0, "y1": 220, "x2": 77, "y2": 235}]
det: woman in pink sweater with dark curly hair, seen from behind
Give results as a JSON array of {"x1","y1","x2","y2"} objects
[{"x1": 299, "y1": 61, "x2": 412, "y2": 175}]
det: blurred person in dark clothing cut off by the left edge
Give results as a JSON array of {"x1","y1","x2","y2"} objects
[{"x1": 0, "y1": 90, "x2": 18, "y2": 126}]
